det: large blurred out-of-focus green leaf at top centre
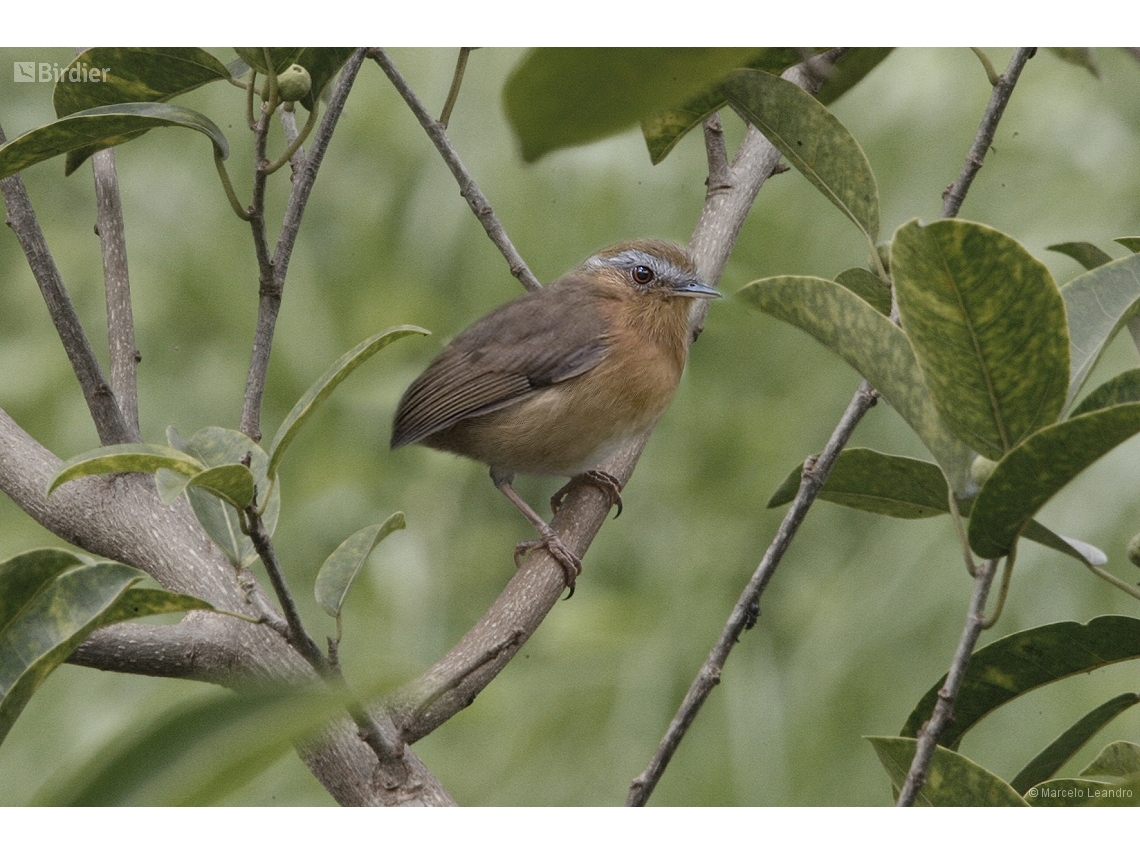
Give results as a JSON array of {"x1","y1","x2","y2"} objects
[{"x1": 503, "y1": 48, "x2": 758, "y2": 161}]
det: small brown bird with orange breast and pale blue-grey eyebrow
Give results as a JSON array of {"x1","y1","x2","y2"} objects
[{"x1": 392, "y1": 239, "x2": 720, "y2": 593}]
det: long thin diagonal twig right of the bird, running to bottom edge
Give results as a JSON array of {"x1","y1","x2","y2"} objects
[{"x1": 626, "y1": 380, "x2": 878, "y2": 807}]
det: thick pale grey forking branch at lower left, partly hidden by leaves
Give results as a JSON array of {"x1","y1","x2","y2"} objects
[{"x1": 0, "y1": 401, "x2": 454, "y2": 805}]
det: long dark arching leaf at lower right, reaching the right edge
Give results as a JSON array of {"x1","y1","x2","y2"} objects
[{"x1": 901, "y1": 614, "x2": 1140, "y2": 748}]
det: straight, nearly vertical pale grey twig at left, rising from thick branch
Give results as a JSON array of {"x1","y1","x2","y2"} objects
[{"x1": 91, "y1": 148, "x2": 143, "y2": 442}]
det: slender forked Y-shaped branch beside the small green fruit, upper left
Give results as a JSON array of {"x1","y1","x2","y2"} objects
[{"x1": 239, "y1": 49, "x2": 364, "y2": 441}]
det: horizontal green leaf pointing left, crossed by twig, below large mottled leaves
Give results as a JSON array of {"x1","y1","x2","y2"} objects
[{"x1": 768, "y1": 448, "x2": 950, "y2": 520}]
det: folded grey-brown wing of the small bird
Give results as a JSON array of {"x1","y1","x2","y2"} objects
[{"x1": 392, "y1": 286, "x2": 609, "y2": 448}]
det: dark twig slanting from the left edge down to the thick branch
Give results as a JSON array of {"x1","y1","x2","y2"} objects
[{"x1": 0, "y1": 121, "x2": 131, "y2": 446}]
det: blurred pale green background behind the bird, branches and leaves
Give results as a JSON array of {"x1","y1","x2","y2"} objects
[{"x1": 0, "y1": 48, "x2": 1140, "y2": 805}]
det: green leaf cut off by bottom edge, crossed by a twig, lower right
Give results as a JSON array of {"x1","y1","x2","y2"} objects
[{"x1": 864, "y1": 736, "x2": 1027, "y2": 807}]
